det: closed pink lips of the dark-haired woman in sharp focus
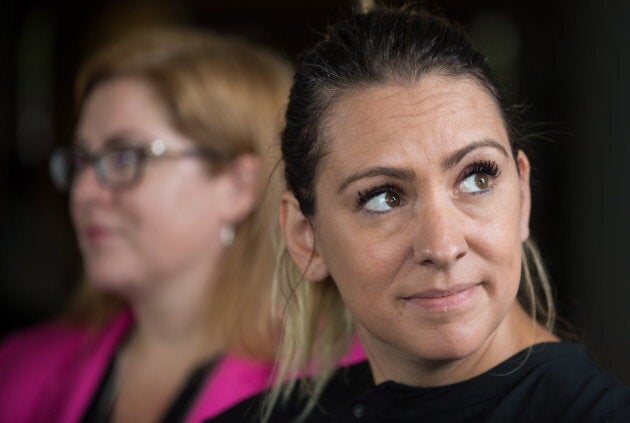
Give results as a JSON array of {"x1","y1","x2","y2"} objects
[{"x1": 404, "y1": 283, "x2": 481, "y2": 312}]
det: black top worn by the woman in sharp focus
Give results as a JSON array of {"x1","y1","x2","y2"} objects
[{"x1": 209, "y1": 343, "x2": 630, "y2": 423}]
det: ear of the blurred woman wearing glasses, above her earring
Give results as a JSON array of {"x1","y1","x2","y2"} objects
[{"x1": 223, "y1": 154, "x2": 262, "y2": 224}]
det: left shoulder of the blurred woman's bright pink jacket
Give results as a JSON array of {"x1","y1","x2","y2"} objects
[{"x1": 0, "y1": 317, "x2": 128, "y2": 422}]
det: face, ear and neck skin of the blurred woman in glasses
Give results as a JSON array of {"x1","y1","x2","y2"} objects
[{"x1": 71, "y1": 77, "x2": 259, "y2": 422}]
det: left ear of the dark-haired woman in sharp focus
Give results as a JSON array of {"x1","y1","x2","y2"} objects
[{"x1": 280, "y1": 191, "x2": 328, "y2": 282}]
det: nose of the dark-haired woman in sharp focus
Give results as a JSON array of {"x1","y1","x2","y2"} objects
[{"x1": 413, "y1": 199, "x2": 468, "y2": 269}]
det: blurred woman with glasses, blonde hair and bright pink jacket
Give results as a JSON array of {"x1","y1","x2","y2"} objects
[{"x1": 0, "y1": 29, "x2": 306, "y2": 422}]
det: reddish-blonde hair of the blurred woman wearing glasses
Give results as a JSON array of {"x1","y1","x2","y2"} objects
[{"x1": 67, "y1": 28, "x2": 292, "y2": 358}]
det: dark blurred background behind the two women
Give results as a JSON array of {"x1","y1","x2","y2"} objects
[{"x1": 0, "y1": 0, "x2": 630, "y2": 383}]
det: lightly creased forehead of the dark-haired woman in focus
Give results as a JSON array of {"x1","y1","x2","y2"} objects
[{"x1": 323, "y1": 75, "x2": 510, "y2": 171}]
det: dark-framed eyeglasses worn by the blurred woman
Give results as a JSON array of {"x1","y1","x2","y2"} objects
[{"x1": 49, "y1": 139, "x2": 217, "y2": 191}]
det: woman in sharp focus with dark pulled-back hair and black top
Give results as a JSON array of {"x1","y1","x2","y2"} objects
[{"x1": 210, "y1": 9, "x2": 630, "y2": 422}]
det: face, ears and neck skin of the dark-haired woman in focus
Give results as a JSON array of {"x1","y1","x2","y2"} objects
[{"x1": 281, "y1": 75, "x2": 556, "y2": 386}]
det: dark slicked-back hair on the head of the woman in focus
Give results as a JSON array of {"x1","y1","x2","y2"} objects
[{"x1": 282, "y1": 8, "x2": 520, "y2": 216}]
